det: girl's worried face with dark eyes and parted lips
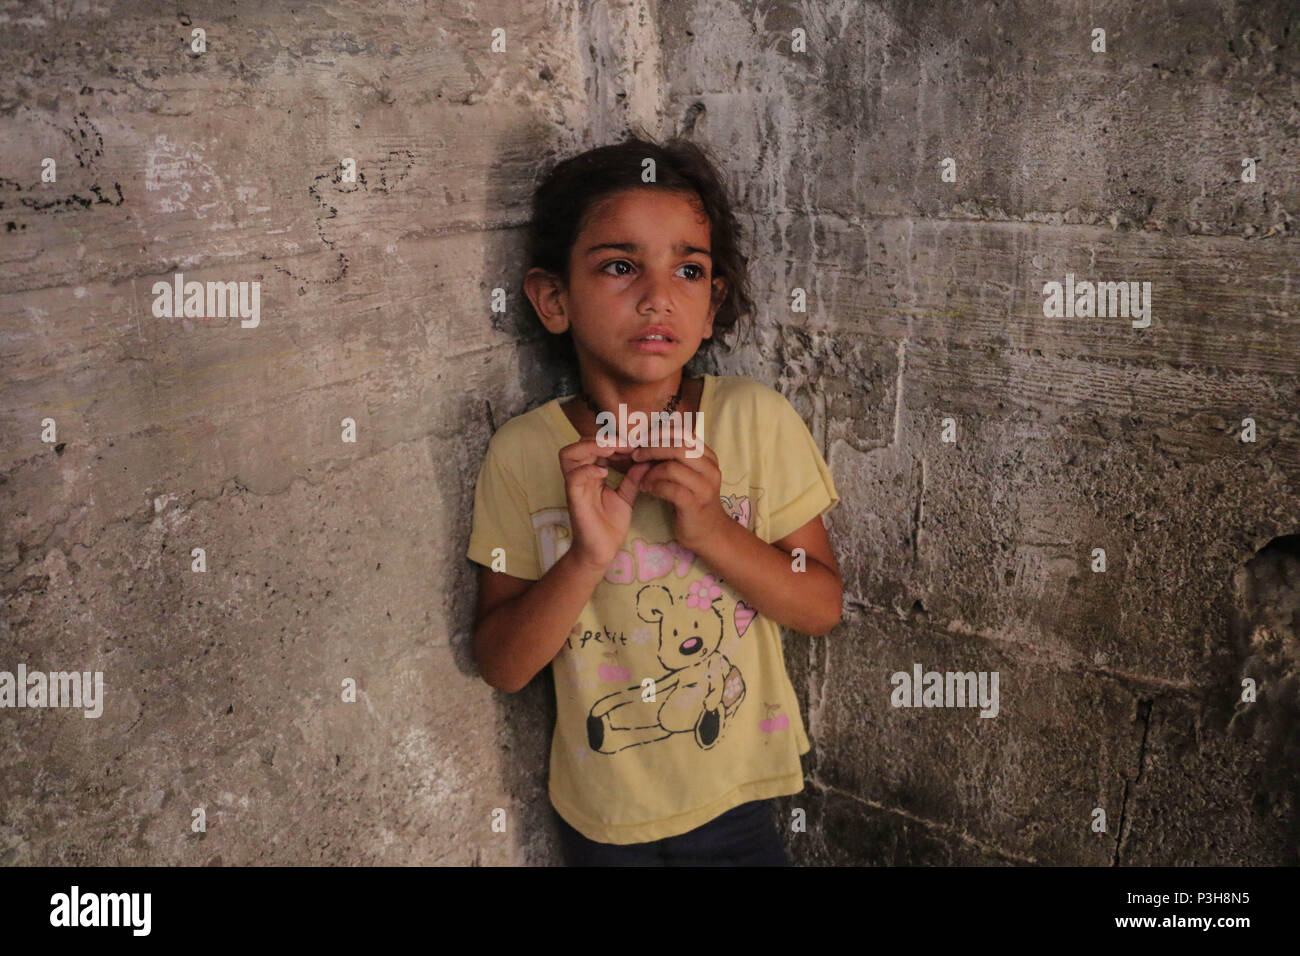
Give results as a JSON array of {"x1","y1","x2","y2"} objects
[{"x1": 553, "y1": 189, "x2": 727, "y2": 384}]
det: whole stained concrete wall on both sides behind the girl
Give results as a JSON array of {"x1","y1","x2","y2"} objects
[{"x1": 0, "y1": 0, "x2": 1300, "y2": 865}]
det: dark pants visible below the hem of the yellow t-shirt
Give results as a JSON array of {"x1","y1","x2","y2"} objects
[{"x1": 551, "y1": 800, "x2": 790, "y2": 866}]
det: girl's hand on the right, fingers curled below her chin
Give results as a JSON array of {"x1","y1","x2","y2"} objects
[{"x1": 629, "y1": 426, "x2": 732, "y2": 554}]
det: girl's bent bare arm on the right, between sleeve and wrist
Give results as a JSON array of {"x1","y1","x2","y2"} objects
[{"x1": 696, "y1": 518, "x2": 844, "y2": 637}]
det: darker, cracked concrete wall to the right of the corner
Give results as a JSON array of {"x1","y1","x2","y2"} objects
[{"x1": 659, "y1": 0, "x2": 1300, "y2": 865}]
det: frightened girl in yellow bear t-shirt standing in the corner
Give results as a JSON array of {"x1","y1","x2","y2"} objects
[{"x1": 468, "y1": 137, "x2": 841, "y2": 866}]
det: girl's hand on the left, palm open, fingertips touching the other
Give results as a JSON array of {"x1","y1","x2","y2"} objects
[{"x1": 559, "y1": 438, "x2": 651, "y2": 571}]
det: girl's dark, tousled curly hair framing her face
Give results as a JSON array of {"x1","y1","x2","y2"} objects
[{"x1": 523, "y1": 130, "x2": 754, "y2": 371}]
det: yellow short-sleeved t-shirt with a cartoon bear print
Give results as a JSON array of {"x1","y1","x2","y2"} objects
[{"x1": 468, "y1": 375, "x2": 840, "y2": 844}]
